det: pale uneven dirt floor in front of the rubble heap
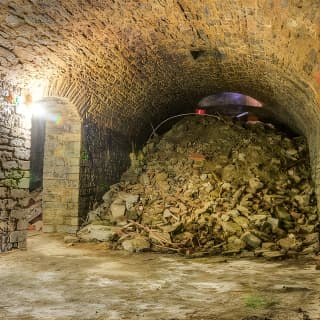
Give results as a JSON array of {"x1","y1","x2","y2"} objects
[{"x1": 0, "y1": 233, "x2": 320, "y2": 320}]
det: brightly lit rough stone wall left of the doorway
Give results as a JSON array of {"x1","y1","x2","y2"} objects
[{"x1": 0, "y1": 83, "x2": 31, "y2": 252}]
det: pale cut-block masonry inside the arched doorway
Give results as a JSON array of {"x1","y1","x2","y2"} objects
[{"x1": 42, "y1": 98, "x2": 81, "y2": 233}]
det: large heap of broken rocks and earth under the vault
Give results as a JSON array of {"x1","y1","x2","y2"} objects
[{"x1": 78, "y1": 116, "x2": 320, "y2": 257}]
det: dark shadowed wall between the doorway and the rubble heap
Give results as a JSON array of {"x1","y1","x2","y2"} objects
[{"x1": 79, "y1": 119, "x2": 132, "y2": 220}]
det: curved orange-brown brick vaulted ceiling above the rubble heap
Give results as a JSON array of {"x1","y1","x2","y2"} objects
[{"x1": 0, "y1": 0, "x2": 320, "y2": 139}]
